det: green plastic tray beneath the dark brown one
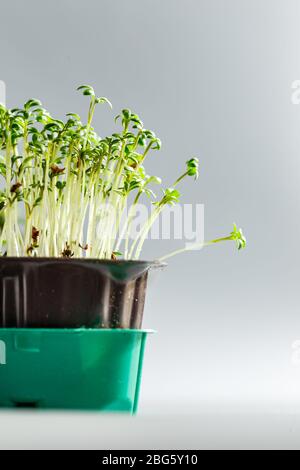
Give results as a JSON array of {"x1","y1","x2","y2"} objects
[{"x1": 0, "y1": 328, "x2": 149, "y2": 413}]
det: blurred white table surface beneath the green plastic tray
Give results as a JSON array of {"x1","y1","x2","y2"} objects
[{"x1": 0, "y1": 404, "x2": 300, "y2": 450}]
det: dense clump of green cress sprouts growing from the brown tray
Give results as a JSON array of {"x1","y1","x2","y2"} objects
[{"x1": 0, "y1": 85, "x2": 246, "y2": 259}]
